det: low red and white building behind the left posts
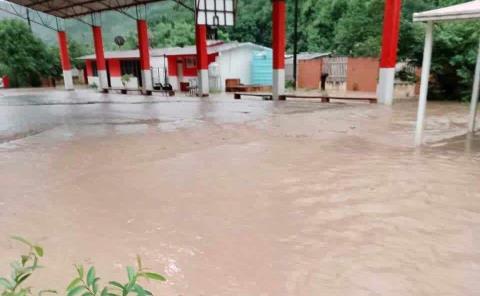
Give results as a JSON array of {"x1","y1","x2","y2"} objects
[{"x1": 79, "y1": 41, "x2": 272, "y2": 91}]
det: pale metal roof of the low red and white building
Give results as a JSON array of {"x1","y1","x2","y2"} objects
[{"x1": 78, "y1": 42, "x2": 271, "y2": 60}]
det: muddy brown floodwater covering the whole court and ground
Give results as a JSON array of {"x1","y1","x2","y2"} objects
[{"x1": 0, "y1": 90, "x2": 480, "y2": 296}]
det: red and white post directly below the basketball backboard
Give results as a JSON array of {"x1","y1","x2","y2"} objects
[{"x1": 195, "y1": 24, "x2": 210, "y2": 97}]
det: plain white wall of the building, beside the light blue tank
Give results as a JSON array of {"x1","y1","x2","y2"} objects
[{"x1": 216, "y1": 46, "x2": 254, "y2": 90}]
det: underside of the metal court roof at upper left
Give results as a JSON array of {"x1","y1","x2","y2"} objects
[{"x1": 4, "y1": 0, "x2": 163, "y2": 18}]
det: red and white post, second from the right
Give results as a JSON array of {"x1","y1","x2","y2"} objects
[{"x1": 272, "y1": 0, "x2": 286, "y2": 100}]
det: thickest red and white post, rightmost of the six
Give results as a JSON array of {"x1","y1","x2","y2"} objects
[{"x1": 377, "y1": 0, "x2": 402, "y2": 105}]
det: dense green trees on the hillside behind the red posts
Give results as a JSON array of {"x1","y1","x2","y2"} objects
[{"x1": 0, "y1": 0, "x2": 480, "y2": 99}]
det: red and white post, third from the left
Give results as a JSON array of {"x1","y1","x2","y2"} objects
[{"x1": 137, "y1": 19, "x2": 153, "y2": 94}]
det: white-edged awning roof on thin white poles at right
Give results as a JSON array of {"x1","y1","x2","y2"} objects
[{"x1": 413, "y1": 0, "x2": 480, "y2": 22}]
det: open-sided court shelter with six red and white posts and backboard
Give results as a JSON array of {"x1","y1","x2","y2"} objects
[{"x1": 0, "y1": 0, "x2": 408, "y2": 105}]
